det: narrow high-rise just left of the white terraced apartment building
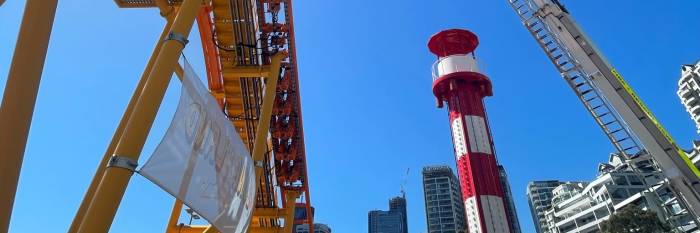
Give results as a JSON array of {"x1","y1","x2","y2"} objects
[{"x1": 527, "y1": 180, "x2": 561, "y2": 233}]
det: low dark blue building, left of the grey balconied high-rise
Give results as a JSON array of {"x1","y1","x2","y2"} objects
[{"x1": 367, "y1": 197, "x2": 408, "y2": 233}]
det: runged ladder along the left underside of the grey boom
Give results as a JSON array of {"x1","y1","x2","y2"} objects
[{"x1": 508, "y1": 0, "x2": 689, "y2": 227}]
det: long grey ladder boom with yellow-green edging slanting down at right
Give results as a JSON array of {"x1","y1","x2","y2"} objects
[{"x1": 508, "y1": 0, "x2": 700, "y2": 228}]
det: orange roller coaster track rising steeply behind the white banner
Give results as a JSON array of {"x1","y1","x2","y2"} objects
[{"x1": 197, "y1": 0, "x2": 313, "y2": 231}]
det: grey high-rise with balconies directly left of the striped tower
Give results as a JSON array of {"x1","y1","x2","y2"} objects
[{"x1": 423, "y1": 166, "x2": 467, "y2": 233}]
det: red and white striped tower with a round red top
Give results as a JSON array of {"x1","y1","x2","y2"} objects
[{"x1": 428, "y1": 29, "x2": 511, "y2": 233}]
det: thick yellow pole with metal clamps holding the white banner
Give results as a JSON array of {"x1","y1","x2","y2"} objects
[{"x1": 78, "y1": 0, "x2": 202, "y2": 233}]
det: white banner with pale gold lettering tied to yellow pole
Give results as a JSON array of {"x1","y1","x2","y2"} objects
[{"x1": 139, "y1": 59, "x2": 255, "y2": 233}]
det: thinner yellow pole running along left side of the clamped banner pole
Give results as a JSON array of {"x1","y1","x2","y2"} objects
[{"x1": 68, "y1": 4, "x2": 173, "y2": 233}]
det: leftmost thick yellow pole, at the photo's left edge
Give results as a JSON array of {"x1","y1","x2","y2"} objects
[{"x1": 0, "y1": 0, "x2": 58, "y2": 232}]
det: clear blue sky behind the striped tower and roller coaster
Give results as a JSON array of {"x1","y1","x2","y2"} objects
[{"x1": 0, "y1": 0, "x2": 700, "y2": 233}]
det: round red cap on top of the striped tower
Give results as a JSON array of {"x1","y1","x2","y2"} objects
[{"x1": 428, "y1": 29, "x2": 479, "y2": 57}]
